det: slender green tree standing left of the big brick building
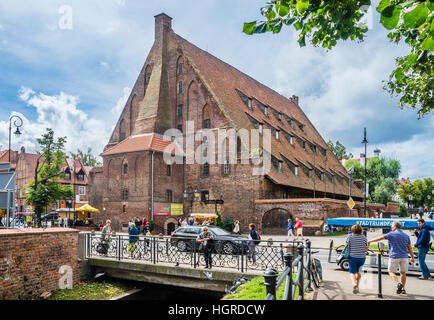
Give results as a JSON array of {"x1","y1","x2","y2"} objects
[{"x1": 26, "y1": 129, "x2": 74, "y2": 224}]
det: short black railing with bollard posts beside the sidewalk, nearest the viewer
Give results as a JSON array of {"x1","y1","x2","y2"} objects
[{"x1": 264, "y1": 240, "x2": 319, "y2": 300}]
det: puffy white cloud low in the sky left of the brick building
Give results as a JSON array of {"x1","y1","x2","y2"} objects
[{"x1": 0, "y1": 87, "x2": 131, "y2": 159}]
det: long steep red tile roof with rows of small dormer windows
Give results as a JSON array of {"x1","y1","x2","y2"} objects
[{"x1": 170, "y1": 32, "x2": 363, "y2": 197}]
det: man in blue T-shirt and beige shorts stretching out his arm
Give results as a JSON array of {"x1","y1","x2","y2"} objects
[{"x1": 368, "y1": 220, "x2": 414, "y2": 294}]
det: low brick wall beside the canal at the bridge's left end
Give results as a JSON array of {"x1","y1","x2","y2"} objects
[{"x1": 0, "y1": 228, "x2": 79, "y2": 300}]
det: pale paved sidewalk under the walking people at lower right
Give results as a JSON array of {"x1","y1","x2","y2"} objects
[{"x1": 307, "y1": 267, "x2": 434, "y2": 300}]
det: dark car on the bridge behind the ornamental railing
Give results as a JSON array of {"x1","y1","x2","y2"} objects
[{"x1": 170, "y1": 226, "x2": 249, "y2": 254}]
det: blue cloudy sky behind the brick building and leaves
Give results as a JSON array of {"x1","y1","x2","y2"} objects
[{"x1": 0, "y1": 0, "x2": 434, "y2": 179}]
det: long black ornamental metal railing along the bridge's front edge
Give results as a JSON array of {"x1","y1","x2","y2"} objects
[{"x1": 86, "y1": 232, "x2": 307, "y2": 272}]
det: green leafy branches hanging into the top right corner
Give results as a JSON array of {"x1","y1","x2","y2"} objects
[{"x1": 243, "y1": 0, "x2": 434, "y2": 117}]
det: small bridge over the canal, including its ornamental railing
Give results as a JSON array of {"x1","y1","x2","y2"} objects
[{"x1": 79, "y1": 232, "x2": 299, "y2": 292}]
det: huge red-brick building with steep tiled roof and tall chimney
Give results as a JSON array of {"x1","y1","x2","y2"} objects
[{"x1": 90, "y1": 14, "x2": 363, "y2": 230}]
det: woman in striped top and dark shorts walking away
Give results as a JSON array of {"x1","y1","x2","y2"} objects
[{"x1": 345, "y1": 224, "x2": 368, "y2": 294}]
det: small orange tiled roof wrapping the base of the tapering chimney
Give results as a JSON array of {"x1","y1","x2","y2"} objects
[{"x1": 101, "y1": 133, "x2": 182, "y2": 156}]
